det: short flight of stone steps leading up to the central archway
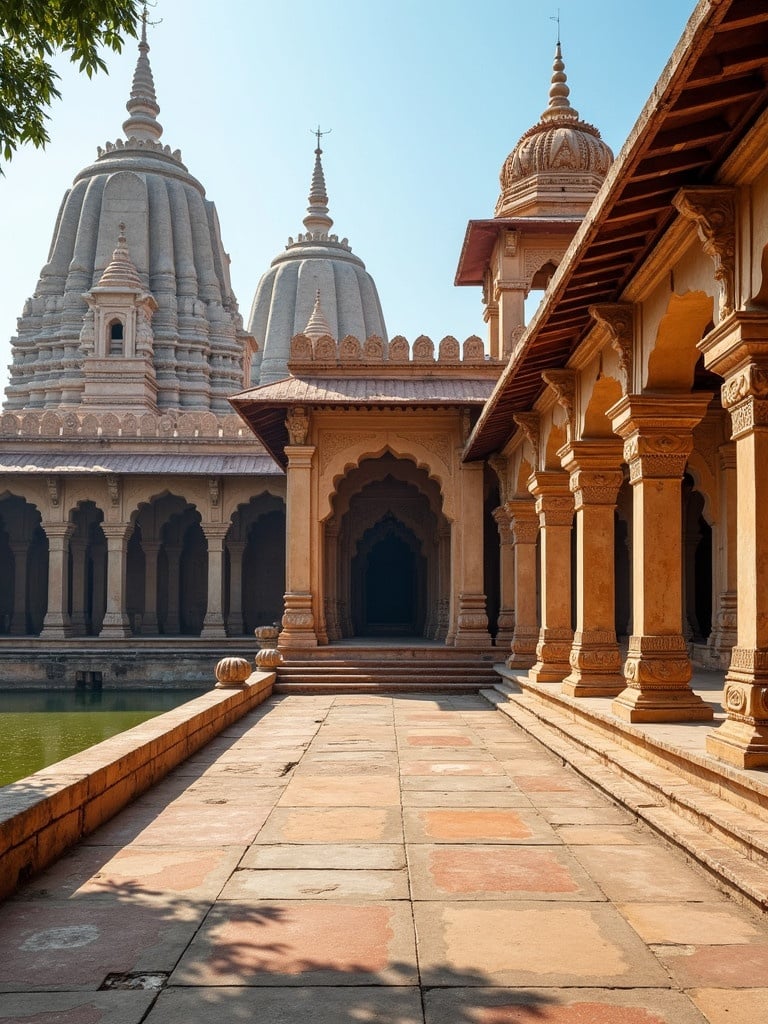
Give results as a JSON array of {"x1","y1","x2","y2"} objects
[{"x1": 274, "y1": 643, "x2": 499, "y2": 693}]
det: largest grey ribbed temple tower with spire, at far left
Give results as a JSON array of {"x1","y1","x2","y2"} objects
[{"x1": 6, "y1": 17, "x2": 252, "y2": 412}]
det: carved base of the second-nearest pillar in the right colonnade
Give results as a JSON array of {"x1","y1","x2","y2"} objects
[{"x1": 610, "y1": 636, "x2": 714, "y2": 722}]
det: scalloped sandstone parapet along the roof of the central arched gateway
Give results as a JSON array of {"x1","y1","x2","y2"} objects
[{"x1": 288, "y1": 334, "x2": 502, "y2": 377}]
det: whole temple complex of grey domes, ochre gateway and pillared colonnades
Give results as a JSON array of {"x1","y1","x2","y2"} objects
[{"x1": 0, "y1": 0, "x2": 768, "y2": 767}]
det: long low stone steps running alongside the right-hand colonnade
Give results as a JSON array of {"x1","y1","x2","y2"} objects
[{"x1": 481, "y1": 666, "x2": 768, "y2": 912}]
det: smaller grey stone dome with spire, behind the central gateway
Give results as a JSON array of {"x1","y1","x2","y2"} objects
[{"x1": 249, "y1": 138, "x2": 387, "y2": 384}]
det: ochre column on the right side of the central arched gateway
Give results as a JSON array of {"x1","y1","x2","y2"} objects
[{"x1": 454, "y1": 462, "x2": 490, "y2": 647}]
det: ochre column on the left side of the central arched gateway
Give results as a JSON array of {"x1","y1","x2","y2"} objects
[{"x1": 279, "y1": 444, "x2": 317, "y2": 647}]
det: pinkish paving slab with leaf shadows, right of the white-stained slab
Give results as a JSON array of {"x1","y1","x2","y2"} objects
[{"x1": 171, "y1": 900, "x2": 417, "y2": 985}]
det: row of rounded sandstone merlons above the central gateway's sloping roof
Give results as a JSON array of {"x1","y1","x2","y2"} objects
[{"x1": 288, "y1": 334, "x2": 487, "y2": 372}]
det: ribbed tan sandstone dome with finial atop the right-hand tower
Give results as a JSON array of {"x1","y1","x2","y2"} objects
[{"x1": 496, "y1": 42, "x2": 613, "y2": 217}]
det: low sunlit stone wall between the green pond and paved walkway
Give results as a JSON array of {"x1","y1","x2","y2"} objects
[{"x1": 0, "y1": 672, "x2": 274, "y2": 898}]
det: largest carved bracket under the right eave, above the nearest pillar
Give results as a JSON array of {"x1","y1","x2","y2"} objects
[{"x1": 672, "y1": 186, "x2": 736, "y2": 321}]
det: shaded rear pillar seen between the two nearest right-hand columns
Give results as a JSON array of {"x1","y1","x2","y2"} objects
[{"x1": 710, "y1": 441, "x2": 738, "y2": 664}]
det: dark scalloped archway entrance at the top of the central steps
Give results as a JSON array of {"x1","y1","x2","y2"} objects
[{"x1": 325, "y1": 454, "x2": 451, "y2": 640}]
